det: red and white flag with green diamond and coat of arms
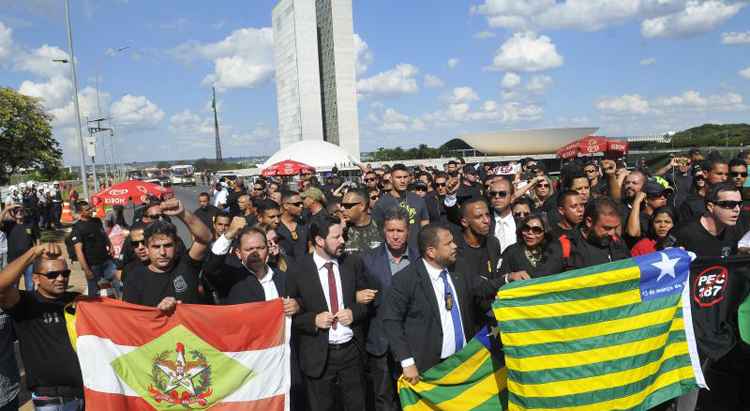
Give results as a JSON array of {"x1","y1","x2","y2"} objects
[{"x1": 73, "y1": 298, "x2": 290, "y2": 411}]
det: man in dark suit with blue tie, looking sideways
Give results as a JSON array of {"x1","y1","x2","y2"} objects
[{"x1": 383, "y1": 224, "x2": 504, "y2": 384}]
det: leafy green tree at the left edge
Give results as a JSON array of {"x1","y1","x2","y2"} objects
[{"x1": 0, "y1": 87, "x2": 62, "y2": 184}]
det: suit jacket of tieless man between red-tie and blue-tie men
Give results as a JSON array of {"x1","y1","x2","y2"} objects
[{"x1": 362, "y1": 243, "x2": 419, "y2": 356}]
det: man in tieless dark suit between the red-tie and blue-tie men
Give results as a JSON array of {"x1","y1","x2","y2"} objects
[{"x1": 362, "y1": 208, "x2": 419, "y2": 411}]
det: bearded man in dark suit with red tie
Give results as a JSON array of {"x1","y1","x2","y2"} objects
[{"x1": 287, "y1": 216, "x2": 367, "y2": 411}]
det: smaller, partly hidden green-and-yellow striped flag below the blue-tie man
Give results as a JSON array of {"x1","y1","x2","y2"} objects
[{"x1": 398, "y1": 327, "x2": 507, "y2": 411}]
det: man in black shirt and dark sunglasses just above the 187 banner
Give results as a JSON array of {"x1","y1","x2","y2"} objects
[{"x1": 675, "y1": 182, "x2": 745, "y2": 257}]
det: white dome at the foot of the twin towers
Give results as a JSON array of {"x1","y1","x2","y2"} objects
[{"x1": 260, "y1": 140, "x2": 356, "y2": 171}]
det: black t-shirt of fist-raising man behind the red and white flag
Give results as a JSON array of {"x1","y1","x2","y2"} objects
[{"x1": 122, "y1": 253, "x2": 202, "y2": 307}]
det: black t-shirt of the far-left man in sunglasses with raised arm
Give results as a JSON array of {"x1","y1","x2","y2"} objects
[{"x1": 8, "y1": 291, "x2": 83, "y2": 395}]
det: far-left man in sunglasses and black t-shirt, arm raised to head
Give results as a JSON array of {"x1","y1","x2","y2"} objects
[{"x1": 0, "y1": 243, "x2": 83, "y2": 411}]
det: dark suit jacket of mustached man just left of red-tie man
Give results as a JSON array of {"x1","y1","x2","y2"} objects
[{"x1": 203, "y1": 252, "x2": 286, "y2": 304}]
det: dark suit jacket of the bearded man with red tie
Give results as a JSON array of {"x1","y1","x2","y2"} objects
[{"x1": 287, "y1": 255, "x2": 367, "y2": 378}]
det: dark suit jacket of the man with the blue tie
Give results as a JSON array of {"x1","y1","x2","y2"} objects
[{"x1": 383, "y1": 260, "x2": 502, "y2": 372}]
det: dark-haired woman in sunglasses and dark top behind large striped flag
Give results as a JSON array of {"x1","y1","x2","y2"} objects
[{"x1": 499, "y1": 213, "x2": 564, "y2": 278}]
